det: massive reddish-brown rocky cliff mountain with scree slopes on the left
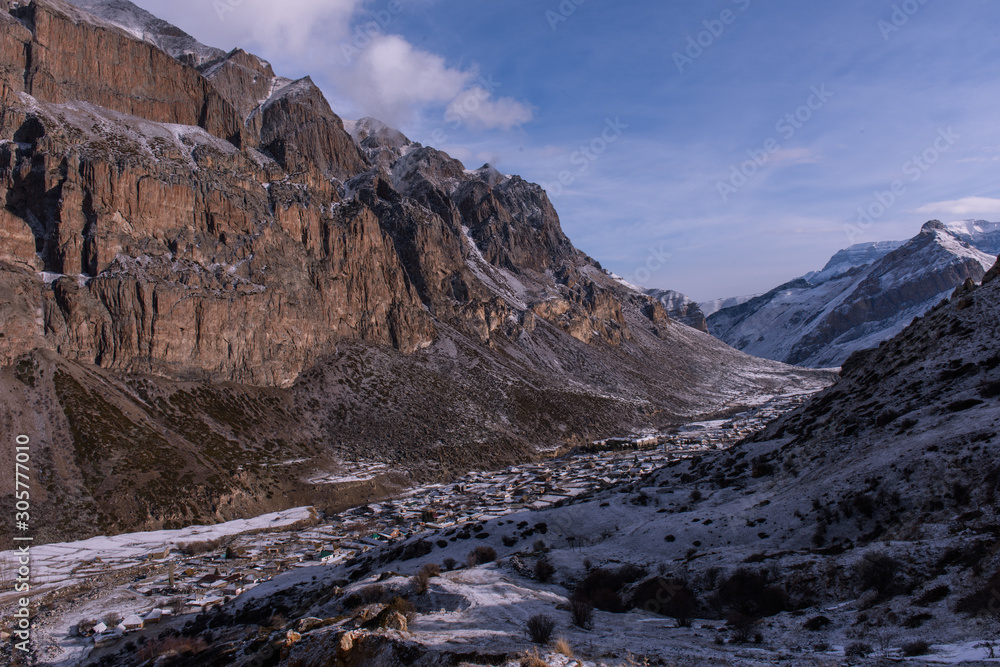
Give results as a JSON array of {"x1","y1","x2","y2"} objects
[{"x1": 0, "y1": 0, "x2": 829, "y2": 541}]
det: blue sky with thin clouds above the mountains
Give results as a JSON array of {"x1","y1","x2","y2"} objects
[{"x1": 129, "y1": 0, "x2": 1000, "y2": 300}]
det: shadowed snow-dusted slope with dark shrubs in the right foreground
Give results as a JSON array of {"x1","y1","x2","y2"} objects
[{"x1": 115, "y1": 254, "x2": 1000, "y2": 667}]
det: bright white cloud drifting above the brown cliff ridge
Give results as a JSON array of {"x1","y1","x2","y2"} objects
[{"x1": 138, "y1": 0, "x2": 533, "y2": 130}]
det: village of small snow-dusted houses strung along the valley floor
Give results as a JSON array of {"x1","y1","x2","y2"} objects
[{"x1": 0, "y1": 394, "x2": 808, "y2": 650}]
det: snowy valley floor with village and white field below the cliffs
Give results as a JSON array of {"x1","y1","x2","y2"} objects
[{"x1": 0, "y1": 393, "x2": 810, "y2": 665}]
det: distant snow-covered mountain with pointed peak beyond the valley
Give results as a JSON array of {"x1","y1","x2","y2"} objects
[{"x1": 708, "y1": 221, "x2": 998, "y2": 367}]
